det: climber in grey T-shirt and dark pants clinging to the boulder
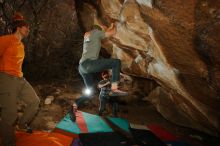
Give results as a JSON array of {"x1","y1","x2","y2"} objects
[{"x1": 76, "y1": 20, "x2": 128, "y2": 106}]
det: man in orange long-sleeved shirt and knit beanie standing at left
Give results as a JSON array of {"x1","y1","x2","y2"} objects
[{"x1": 0, "y1": 13, "x2": 40, "y2": 146}]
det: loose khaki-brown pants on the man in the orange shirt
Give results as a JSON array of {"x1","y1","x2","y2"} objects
[{"x1": 0, "y1": 73, "x2": 40, "y2": 146}]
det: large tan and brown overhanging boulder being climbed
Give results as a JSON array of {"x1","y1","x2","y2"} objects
[{"x1": 75, "y1": 0, "x2": 220, "y2": 136}]
